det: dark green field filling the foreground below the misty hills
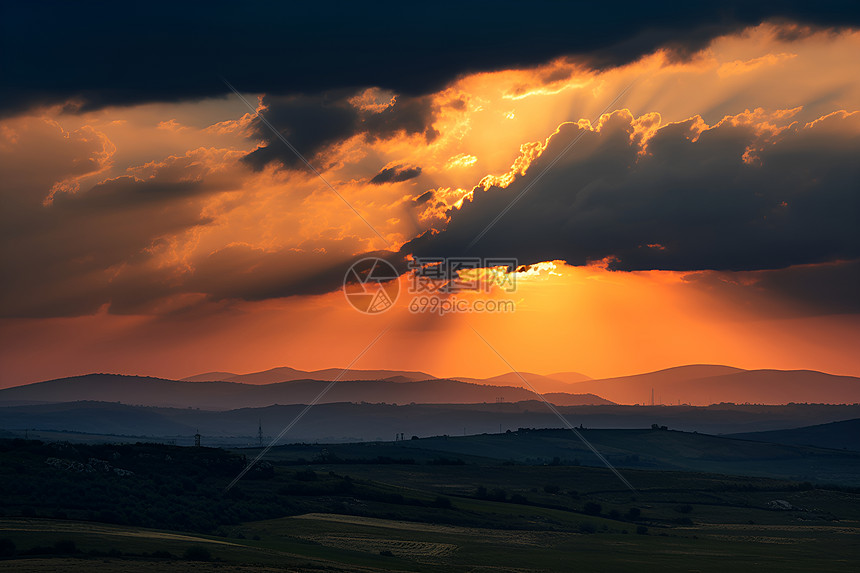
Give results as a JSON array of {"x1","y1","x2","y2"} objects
[{"x1": 0, "y1": 432, "x2": 860, "y2": 572}]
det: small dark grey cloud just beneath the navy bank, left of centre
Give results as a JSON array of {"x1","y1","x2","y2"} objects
[{"x1": 245, "y1": 91, "x2": 437, "y2": 170}]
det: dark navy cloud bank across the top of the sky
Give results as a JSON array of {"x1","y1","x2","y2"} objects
[{"x1": 0, "y1": 0, "x2": 860, "y2": 115}]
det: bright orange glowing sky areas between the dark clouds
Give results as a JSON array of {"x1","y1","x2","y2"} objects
[{"x1": 0, "y1": 25, "x2": 860, "y2": 387}]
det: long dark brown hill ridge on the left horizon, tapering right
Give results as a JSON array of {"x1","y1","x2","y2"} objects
[{"x1": 0, "y1": 374, "x2": 610, "y2": 410}]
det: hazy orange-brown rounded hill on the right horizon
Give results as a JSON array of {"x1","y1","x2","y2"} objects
[{"x1": 570, "y1": 365, "x2": 860, "y2": 406}]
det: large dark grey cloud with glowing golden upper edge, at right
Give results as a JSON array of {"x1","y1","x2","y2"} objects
[{"x1": 403, "y1": 111, "x2": 860, "y2": 271}]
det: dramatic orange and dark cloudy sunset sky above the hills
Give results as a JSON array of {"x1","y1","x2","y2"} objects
[{"x1": 0, "y1": 2, "x2": 860, "y2": 387}]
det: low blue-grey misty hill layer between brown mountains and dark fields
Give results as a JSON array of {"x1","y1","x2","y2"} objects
[{"x1": 6, "y1": 400, "x2": 860, "y2": 445}]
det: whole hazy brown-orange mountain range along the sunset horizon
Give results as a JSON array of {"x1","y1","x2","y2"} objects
[{"x1": 0, "y1": 364, "x2": 860, "y2": 410}]
